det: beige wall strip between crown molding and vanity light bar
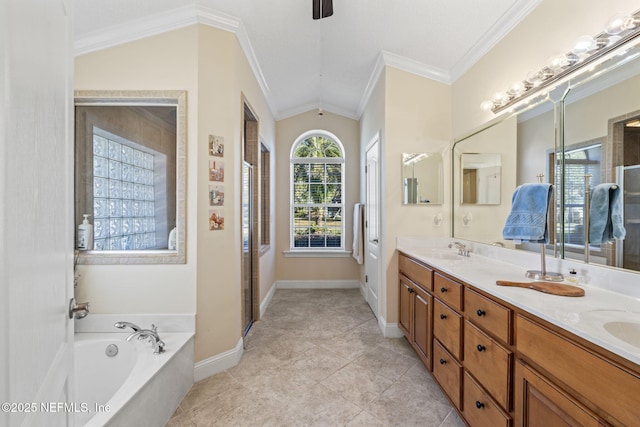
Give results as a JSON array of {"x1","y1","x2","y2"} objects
[{"x1": 452, "y1": 0, "x2": 638, "y2": 137}]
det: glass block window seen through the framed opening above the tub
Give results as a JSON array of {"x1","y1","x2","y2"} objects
[{"x1": 93, "y1": 129, "x2": 160, "y2": 251}]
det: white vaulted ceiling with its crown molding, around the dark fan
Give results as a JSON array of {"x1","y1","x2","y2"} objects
[{"x1": 74, "y1": 0, "x2": 541, "y2": 119}]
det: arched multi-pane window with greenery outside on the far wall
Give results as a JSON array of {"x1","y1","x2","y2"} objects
[{"x1": 290, "y1": 131, "x2": 344, "y2": 251}]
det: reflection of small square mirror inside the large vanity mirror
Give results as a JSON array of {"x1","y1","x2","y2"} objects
[{"x1": 460, "y1": 153, "x2": 501, "y2": 205}]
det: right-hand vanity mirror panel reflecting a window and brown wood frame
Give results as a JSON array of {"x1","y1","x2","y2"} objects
[{"x1": 563, "y1": 41, "x2": 640, "y2": 271}]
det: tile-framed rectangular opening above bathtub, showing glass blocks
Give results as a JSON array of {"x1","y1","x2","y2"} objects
[{"x1": 74, "y1": 91, "x2": 186, "y2": 264}]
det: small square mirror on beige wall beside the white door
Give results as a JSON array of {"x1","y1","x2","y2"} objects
[{"x1": 402, "y1": 153, "x2": 444, "y2": 205}]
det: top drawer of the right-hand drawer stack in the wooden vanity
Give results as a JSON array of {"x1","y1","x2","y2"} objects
[{"x1": 464, "y1": 289, "x2": 513, "y2": 344}]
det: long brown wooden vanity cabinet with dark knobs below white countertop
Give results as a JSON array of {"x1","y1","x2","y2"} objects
[{"x1": 398, "y1": 251, "x2": 640, "y2": 427}]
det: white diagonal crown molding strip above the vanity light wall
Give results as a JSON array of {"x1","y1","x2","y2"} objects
[{"x1": 450, "y1": 0, "x2": 542, "y2": 83}]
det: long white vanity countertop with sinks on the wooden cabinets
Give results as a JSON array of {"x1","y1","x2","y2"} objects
[{"x1": 396, "y1": 237, "x2": 640, "y2": 365}]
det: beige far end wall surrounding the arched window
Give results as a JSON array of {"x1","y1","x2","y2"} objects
[{"x1": 274, "y1": 110, "x2": 361, "y2": 281}]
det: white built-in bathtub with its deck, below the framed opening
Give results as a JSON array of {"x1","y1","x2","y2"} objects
[{"x1": 75, "y1": 314, "x2": 194, "y2": 426}]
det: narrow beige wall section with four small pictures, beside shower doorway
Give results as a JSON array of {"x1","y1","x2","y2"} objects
[{"x1": 195, "y1": 26, "x2": 275, "y2": 361}]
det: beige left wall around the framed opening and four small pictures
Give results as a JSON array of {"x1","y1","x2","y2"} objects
[{"x1": 76, "y1": 26, "x2": 275, "y2": 361}]
